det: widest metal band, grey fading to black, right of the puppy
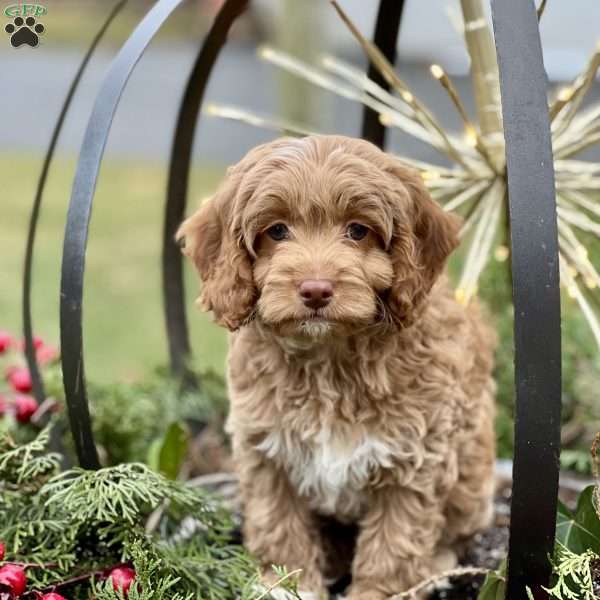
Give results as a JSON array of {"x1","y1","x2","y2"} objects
[{"x1": 492, "y1": 0, "x2": 561, "y2": 600}]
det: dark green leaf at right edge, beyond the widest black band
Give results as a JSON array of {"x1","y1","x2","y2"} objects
[{"x1": 556, "y1": 485, "x2": 600, "y2": 554}]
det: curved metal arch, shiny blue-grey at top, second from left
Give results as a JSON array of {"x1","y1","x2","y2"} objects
[{"x1": 60, "y1": 0, "x2": 191, "y2": 468}]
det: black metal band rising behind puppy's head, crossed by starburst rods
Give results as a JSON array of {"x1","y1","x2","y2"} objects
[{"x1": 362, "y1": 0, "x2": 404, "y2": 148}]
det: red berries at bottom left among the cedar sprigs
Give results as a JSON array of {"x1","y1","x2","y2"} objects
[{"x1": 0, "y1": 542, "x2": 135, "y2": 600}]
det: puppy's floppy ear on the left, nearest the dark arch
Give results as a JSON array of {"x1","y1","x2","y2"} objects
[{"x1": 176, "y1": 173, "x2": 256, "y2": 331}]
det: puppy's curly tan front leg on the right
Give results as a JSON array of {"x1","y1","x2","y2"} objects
[{"x1": 346, "y1": 485, "x2": 444, "y2": 600}]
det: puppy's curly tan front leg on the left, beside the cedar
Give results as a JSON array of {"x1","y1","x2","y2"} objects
[{"x1": 238, "y1": 448, "x2": 325, "y2": 600}]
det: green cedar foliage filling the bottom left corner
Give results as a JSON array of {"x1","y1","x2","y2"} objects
[{"x1": 0, "y1": 428, "x2": 278, "y2": 600}]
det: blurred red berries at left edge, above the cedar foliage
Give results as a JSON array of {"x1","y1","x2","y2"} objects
[{"x1": 0, "y1": 331, "x2": 58, "y2": 423}]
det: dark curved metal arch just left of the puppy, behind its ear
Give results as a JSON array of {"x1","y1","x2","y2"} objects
[{"x1": 162, "y1": 0, "x2": 249, "y2": 385}]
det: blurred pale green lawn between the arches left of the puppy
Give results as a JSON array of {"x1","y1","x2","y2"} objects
[{"x1": 0, "y1": 153, "x2": 226, "y2": 382}]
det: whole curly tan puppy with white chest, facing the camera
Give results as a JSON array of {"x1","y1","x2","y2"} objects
[{"x1": 178, "y1": 136, "x2": 494, "y2": 600}]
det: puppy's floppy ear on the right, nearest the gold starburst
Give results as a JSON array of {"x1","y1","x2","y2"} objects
[{"x1": 387, "y1": 160, "x2": 460, "y2": 327}]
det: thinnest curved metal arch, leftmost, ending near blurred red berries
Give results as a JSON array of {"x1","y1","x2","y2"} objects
[{"x1": 22, "y1": 0, "x2": 127, "y2": 402}]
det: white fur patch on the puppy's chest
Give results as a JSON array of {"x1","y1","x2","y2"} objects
[{"x1": 257, "y1": 430, "x2": 393, "y2": 518}]
